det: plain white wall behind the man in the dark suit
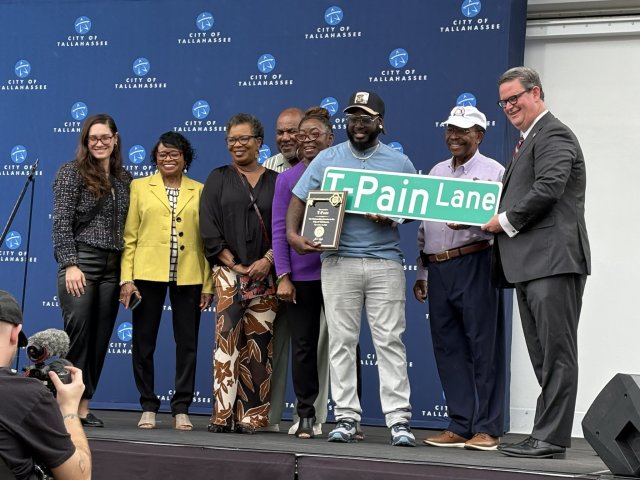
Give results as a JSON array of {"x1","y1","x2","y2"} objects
[{"x1": 511, "y1": 12, "x2": 640, "y2": 437}]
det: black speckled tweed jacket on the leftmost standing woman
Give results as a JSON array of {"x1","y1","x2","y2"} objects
[{"x1": 53, "y1": 160, "x2": 131, "y2": 268}]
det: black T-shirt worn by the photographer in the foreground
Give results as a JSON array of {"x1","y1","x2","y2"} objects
[{"x1": 0, "y1": 368, "x2": 76, "y2": 480}]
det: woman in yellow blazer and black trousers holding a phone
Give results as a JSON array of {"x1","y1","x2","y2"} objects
[{"x1": 120, "y1": 132, "x2": 213, "y2": 430}]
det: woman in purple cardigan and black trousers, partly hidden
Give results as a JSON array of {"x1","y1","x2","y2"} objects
[{"x1": 272, "y1": 107, "x2": 333, "y2": 438}]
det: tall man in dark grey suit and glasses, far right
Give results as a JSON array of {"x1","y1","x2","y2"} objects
[{"x1": 482, "y1": 67, "x2": 591, "y2": 458}]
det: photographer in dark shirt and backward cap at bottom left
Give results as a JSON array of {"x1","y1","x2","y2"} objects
[{"x1": 0, "y1": 290, "x2": 91, "y2": 480}]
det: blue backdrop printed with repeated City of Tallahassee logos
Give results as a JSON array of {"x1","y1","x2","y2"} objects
[{"x1": 0, "y1": 0, "x2": 526, "y2": 428}]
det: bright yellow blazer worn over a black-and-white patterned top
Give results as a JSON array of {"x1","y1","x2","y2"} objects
[{"x1": 120, "y1": 173, "x2": 213, "y2": 293}]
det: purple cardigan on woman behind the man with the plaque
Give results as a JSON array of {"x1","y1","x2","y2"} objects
[{"x1": 271, "y1": 162, "x2": 320, "y2": 282}]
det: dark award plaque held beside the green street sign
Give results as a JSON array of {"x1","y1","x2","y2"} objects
[{"x1": 302, "y1": 190, "x2": 347, "y2": 250}]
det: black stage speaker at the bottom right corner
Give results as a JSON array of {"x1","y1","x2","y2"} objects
[{"x1": 582, "y1": 373, "x2": 640, "y2": 477}]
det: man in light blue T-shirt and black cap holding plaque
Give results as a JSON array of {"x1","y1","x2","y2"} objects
[{"x1": 287, "y1": 91, "x2": 415, "y2": 446}]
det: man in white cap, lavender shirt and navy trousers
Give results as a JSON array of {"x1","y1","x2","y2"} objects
[{"x1": 413, "y1": 106, "x2": 505, "y2": 450}]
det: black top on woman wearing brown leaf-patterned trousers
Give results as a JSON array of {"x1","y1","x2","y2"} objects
[{"x1": 200, "y1": 165, "x2": 278, "y2": 266}]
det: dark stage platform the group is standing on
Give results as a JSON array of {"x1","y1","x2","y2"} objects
[{"x1": 85, "y1": 410, "x2": 614, "y2": 480}]
